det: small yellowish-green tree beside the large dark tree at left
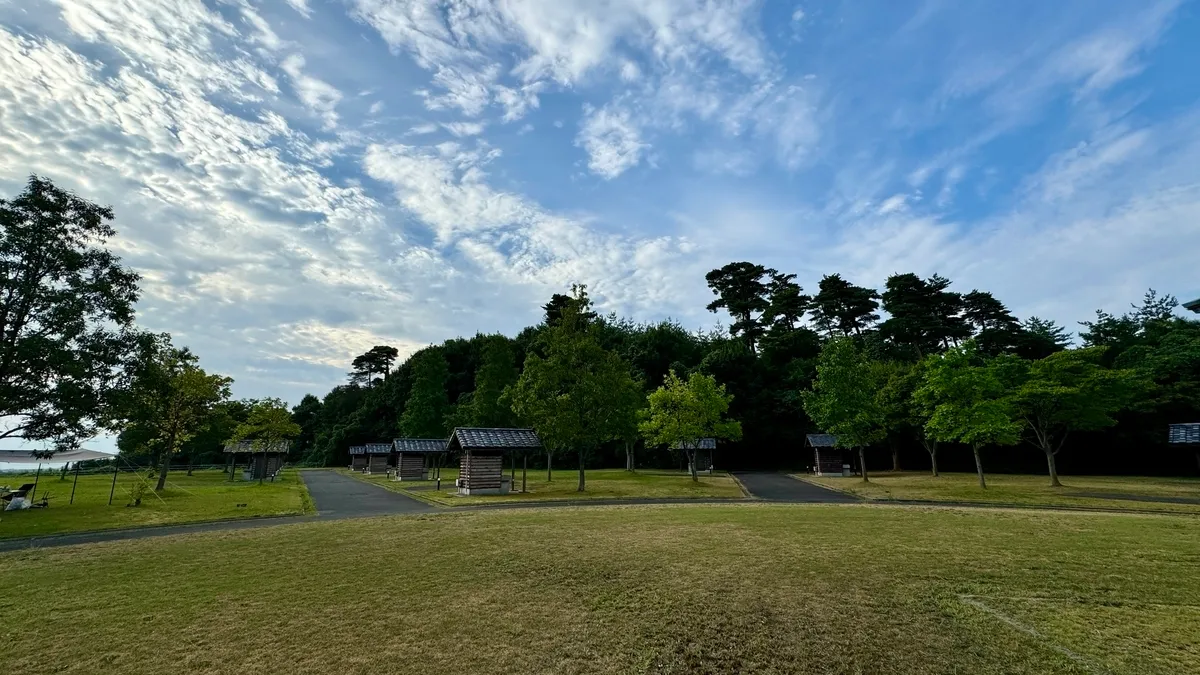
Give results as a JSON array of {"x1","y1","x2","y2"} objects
[{"x1": 121, "y1": 335, "x2": 233, "y2": 491}]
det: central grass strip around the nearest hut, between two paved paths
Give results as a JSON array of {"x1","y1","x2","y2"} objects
[{"x1": 346, "y1": 468, "x2": 745, "y2": 506}]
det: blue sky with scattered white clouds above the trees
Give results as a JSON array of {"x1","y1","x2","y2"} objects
[{"x1": 0, "y1": 0, "x2": 1200, "y2": 425}]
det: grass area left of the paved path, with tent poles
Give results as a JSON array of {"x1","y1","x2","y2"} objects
[{"x1": 0, "y1": 470, "x2": 313, "y2": 539}]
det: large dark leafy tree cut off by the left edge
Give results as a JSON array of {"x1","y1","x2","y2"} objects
[{"x1": 0, "y1": 175, "x2": 139, "y2": 447}]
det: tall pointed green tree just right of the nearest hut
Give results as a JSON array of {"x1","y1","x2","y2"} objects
[{"x1": 508, "y1": 286, "x2": 634, "y2": 492}]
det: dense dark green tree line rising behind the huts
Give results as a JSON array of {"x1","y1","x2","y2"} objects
[{"x1": 293, "y1": 262, "x2": 1200, "y2": 473}]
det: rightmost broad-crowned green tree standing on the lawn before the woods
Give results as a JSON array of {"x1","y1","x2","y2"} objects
[{"x1": 1010, "y1": 347, "x2": 1146, "y2": 488}]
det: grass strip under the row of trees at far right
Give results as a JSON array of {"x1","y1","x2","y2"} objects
[{"x1": 799, "y1": 472, "x2": 1200, "y2": 513}]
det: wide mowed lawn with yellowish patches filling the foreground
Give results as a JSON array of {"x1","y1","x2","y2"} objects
[{"x1": 0, "y1": 503, "x2": 1200, "y2": 675}]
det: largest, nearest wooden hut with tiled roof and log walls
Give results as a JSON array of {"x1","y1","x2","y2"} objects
[{"x1": 446, "y1": 426, "x2": 541, "y2": 495}]
